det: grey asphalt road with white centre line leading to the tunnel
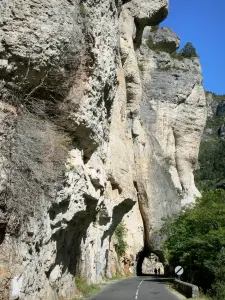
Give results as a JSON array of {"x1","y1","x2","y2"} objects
[{"x1": 90, "y1": 276, "x2": 180, "y2": 300}]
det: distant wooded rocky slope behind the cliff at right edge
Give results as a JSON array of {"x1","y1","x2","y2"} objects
[{"x1": 195, "y1": 92, "x2": 225, "y2": 191}]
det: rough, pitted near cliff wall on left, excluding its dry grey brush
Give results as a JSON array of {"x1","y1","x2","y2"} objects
[{"x1": 0, "y1": 0, "x2": 143, "y2": 300}]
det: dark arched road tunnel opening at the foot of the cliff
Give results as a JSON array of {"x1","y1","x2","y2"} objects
[{"x1": 136, "y1": 250, "x2": 165, "y2": 276}]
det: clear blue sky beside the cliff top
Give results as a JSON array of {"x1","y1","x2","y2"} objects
[{"x1": 160, "y1": 0, "x2": 225, "y2": 94}]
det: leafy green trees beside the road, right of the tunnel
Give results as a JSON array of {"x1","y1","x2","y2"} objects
[{"x1": 162, "y1": 190, "x2": 225, "y2": 300}]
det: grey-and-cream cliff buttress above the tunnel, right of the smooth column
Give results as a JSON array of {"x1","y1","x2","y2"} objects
[{"x1": 135, "y1": 27, "x2": 206, "y2": 253}]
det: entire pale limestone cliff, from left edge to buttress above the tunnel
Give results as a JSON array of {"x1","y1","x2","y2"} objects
[{"x1": 0, "y1": 0, "x2": 206, "y2": 300}]
